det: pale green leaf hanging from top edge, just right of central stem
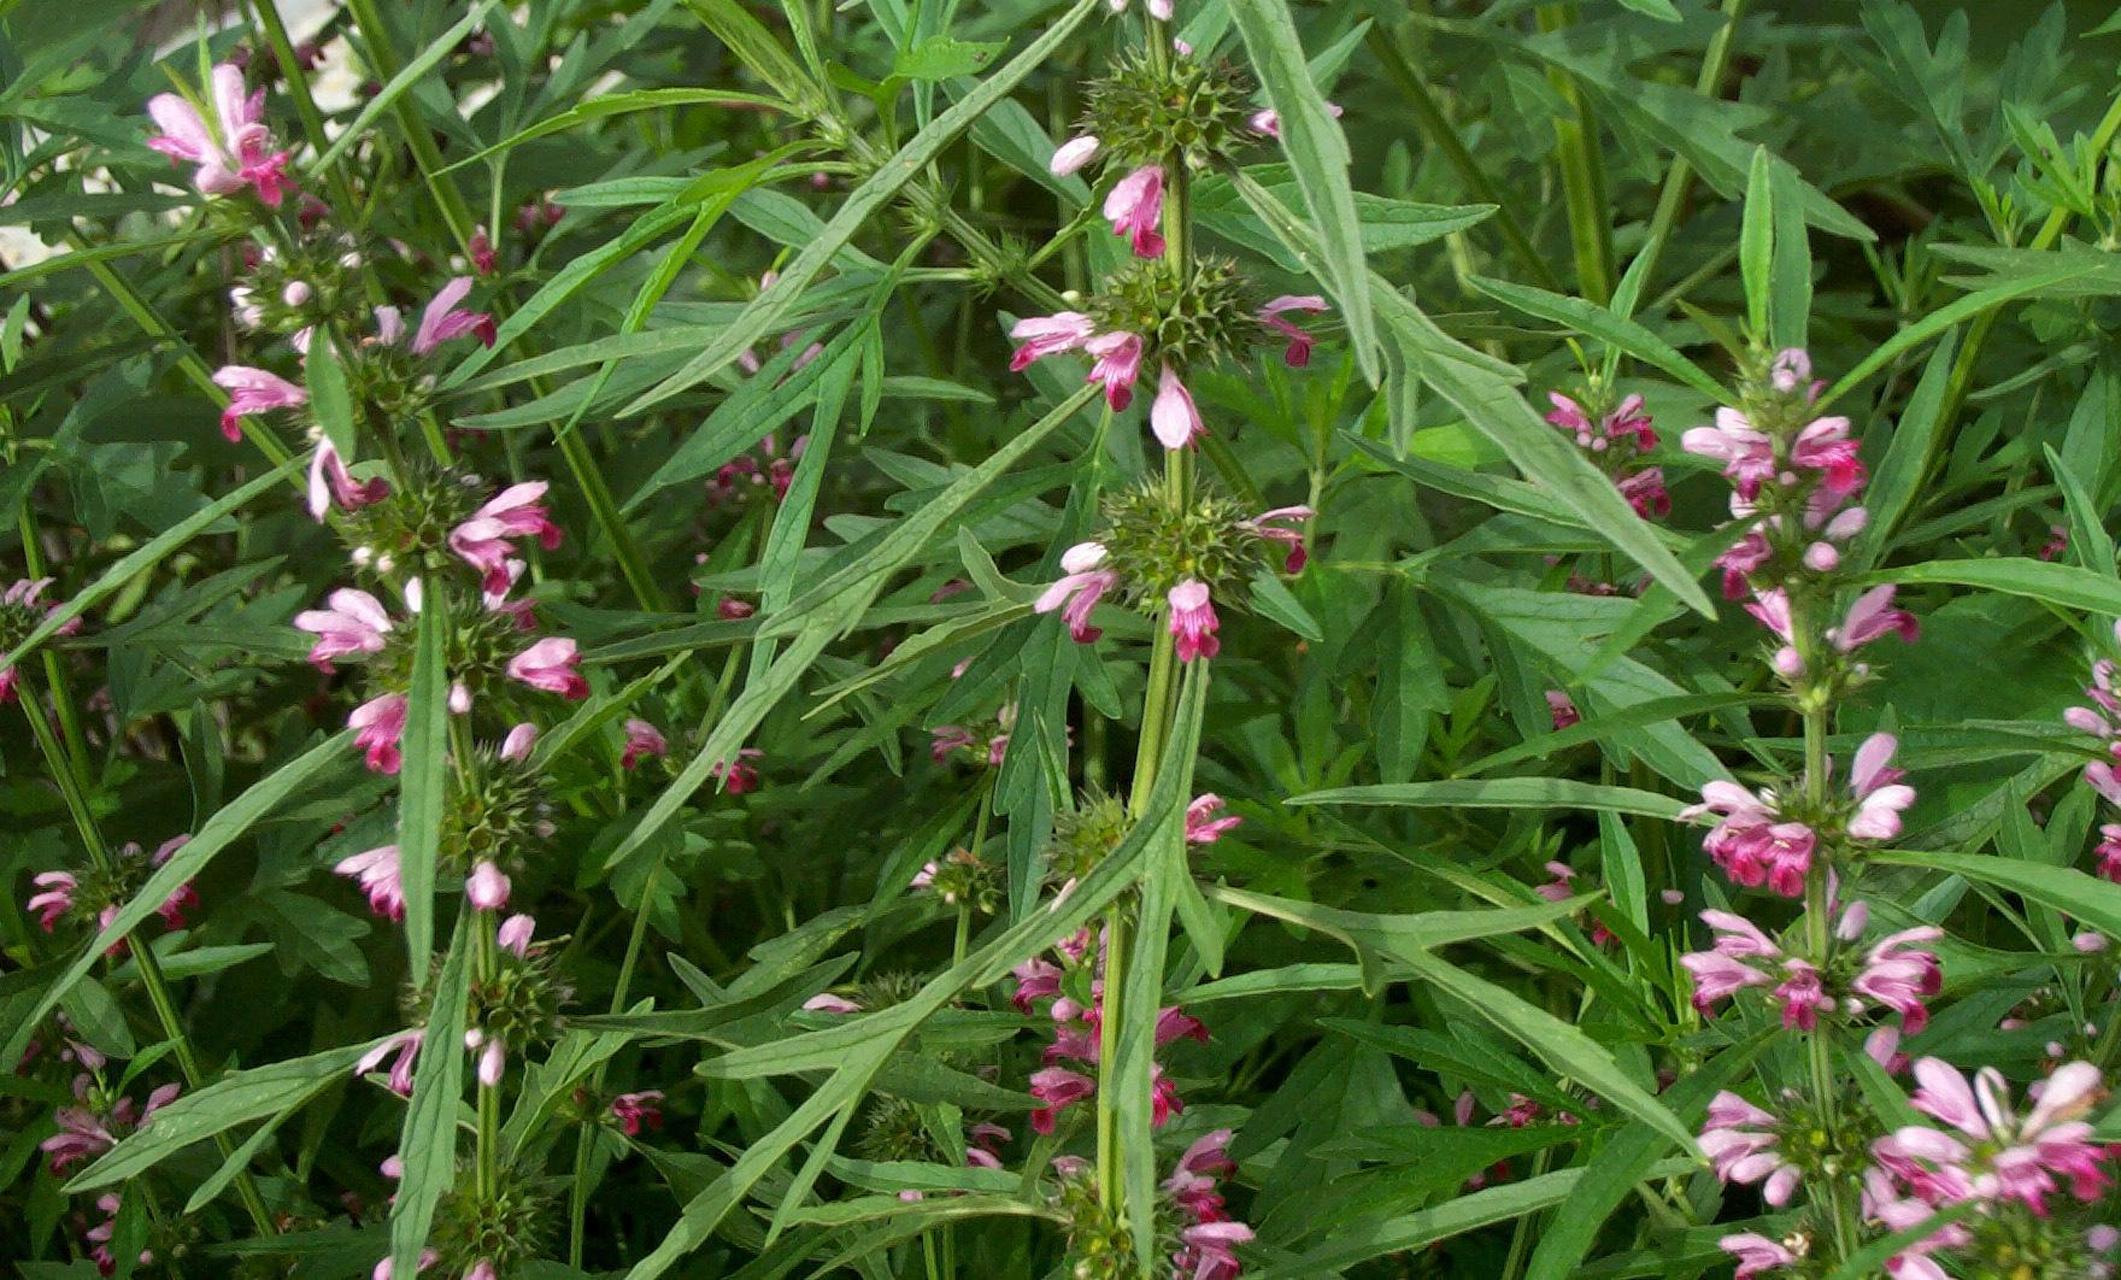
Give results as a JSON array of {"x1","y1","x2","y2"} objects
[{"x1": 1228, "y1": 0, "x2": 1383, "y2": 384}]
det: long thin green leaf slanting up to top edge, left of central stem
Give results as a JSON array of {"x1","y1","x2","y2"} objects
[{"x1": 621, "y1": 0, "x2": 1097, "y2": 416}]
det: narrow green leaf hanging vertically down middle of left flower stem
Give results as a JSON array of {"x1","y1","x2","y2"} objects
[{"x1": 399, "y1": 582, "x2": 450, "y2": 987}]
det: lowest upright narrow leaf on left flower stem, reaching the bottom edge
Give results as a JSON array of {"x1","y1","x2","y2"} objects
[{"x1": 390, "y1": 911, "x2": 475, "y2": 1276}]
